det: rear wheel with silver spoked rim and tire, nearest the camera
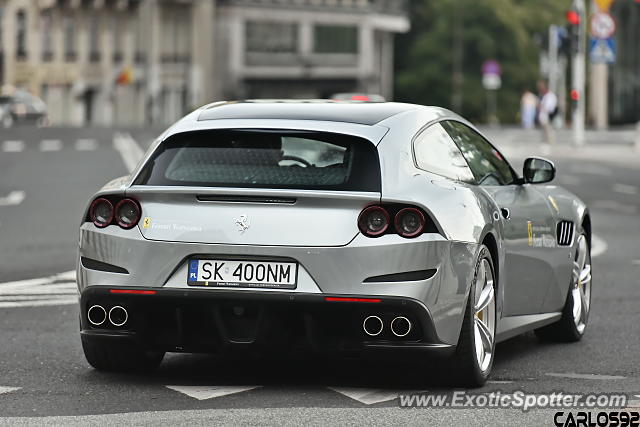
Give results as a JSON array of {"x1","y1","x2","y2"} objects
[{"x1": 450, "y1": 245, "x2": 497, "y2": 387}]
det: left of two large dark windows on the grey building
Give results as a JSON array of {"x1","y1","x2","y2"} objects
[{"x1": 245, "y1": 21, "x2": 298, "y2": 53}]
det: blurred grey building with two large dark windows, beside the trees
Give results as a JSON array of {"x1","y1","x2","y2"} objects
[{"x1": 215, "y1": 0, "x2": 409, "y2": 99}]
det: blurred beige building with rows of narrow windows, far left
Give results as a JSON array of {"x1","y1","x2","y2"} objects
[{"x1": 0, "y1": 0, "x2": 214, "y2": 126}]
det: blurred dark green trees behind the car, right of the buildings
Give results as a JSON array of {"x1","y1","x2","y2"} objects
[{"x1": 396, "y1": 0, "x2": 571, "y2": 122}]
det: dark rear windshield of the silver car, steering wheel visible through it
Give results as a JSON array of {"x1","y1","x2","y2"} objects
[{"x1": 135, "y1": 130, "x2": 380, "y2": 191}]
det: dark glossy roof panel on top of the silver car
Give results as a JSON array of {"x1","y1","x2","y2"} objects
[{"x1": 197, "y1": 100, "x2": 420, "y2": 126}]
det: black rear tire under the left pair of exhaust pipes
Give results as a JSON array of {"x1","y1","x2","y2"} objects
[{"x1": 82, "y1": 340, "x2": 164, "y2": 372}]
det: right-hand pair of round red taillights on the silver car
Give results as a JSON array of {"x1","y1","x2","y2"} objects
[{"x1": 358, "y1": 205, "x2": 428, "y2": 238}]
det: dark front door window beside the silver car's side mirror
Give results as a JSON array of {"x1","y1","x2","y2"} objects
[{"x1": 442, "y1": 121, "x2": 516, "y2": 185}]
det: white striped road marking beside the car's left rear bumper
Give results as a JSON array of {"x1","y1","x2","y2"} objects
[{"x1": 0, "y1": 271, "x2": 78, "y2": 308}]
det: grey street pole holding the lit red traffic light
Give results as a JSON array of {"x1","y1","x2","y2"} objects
[{"x1": 571, "y1": 0, "x2": 587, "y2": 146}]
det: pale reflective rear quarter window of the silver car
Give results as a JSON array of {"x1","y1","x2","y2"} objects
[{"x1": 413, "y1": 123, "x2": 474, "y2": 182}]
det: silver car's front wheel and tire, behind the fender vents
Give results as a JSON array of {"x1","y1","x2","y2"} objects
[{"x1": 535, "y1": 232, "x2": 592, "y2": 342}]
